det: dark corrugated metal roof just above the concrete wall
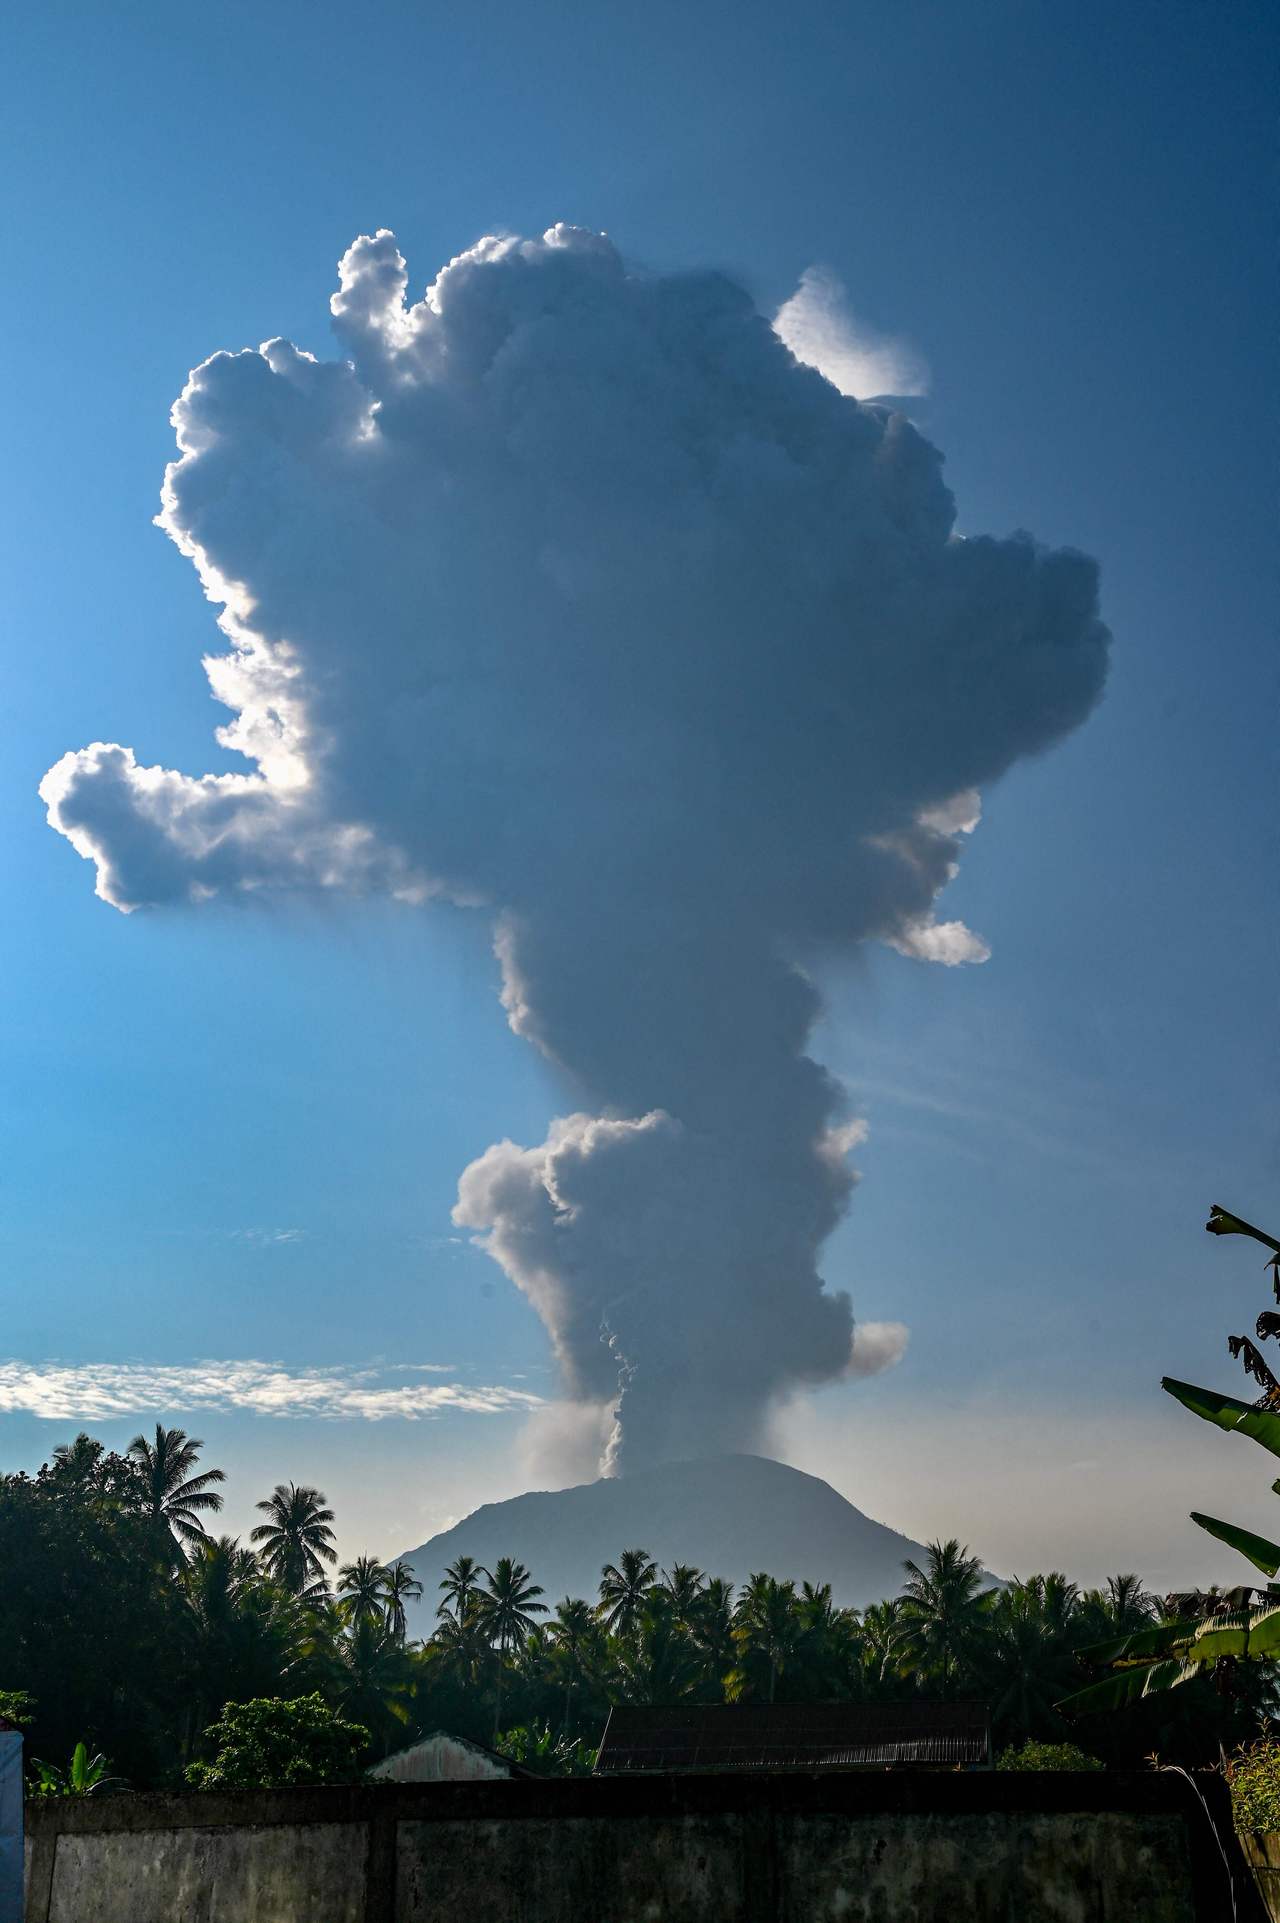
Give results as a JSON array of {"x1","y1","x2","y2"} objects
[{"x1": 596, "y1": 1702, "x2": 992, "y2": 1775}]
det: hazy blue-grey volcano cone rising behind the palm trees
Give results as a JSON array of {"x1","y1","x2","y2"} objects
[{"x1": 398, "y1": 1456, "x2": 926, "y2": 1636}]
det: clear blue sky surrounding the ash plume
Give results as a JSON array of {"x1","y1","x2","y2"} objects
[{"x1": 0, "y1": 0, "x2": 1278, "y2": 1583}]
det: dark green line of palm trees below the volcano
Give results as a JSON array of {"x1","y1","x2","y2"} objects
[{"x1": 0, "y1": 1425, "x2": 1276, "y2": 1786}]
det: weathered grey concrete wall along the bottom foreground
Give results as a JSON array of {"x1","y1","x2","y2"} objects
[{"x1": 27, "y1": 1773, "x2": 1255, "y2": 1923}]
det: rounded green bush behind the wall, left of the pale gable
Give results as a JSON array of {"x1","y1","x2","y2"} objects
[{"x1": 186, "y1": 1692, "x2": 369, "y2": 1790}]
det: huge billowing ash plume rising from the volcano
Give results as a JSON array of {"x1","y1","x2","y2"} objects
[{"x1": 40, "y1": 227, "x2": 1107, "y2": 1463}]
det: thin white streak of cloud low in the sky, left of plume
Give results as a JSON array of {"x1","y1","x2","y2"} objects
[{"x1": 0, "y1": 1360, "x2": 542, "y2": 1423}]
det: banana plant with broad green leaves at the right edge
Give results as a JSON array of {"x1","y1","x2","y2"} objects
[{"x1": 1057, "y1": 1202, "x2": 1280, "y2": 1713}]
